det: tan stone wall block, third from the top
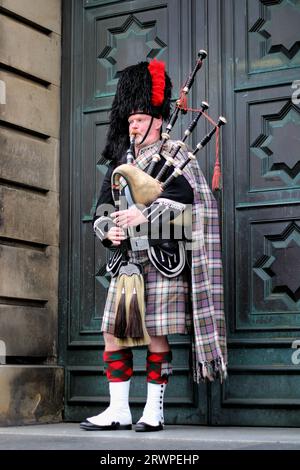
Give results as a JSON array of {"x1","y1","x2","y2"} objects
[{"x1": 0, "y1": 71, "x2": 60, "y2": 138}]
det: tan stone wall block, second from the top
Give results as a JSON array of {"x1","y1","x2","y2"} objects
[{"x1": 0, "y1": 13, "x2": 61, "y2": 86}]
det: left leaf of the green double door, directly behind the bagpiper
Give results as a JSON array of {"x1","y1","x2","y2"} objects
[{"x1": 61, "y1": 0, "x2": 207, "y2": 424}]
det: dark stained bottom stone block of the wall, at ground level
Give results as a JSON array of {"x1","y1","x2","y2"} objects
[{"x1": 0, "y1": 365, "x2": 64, "y2": 426}]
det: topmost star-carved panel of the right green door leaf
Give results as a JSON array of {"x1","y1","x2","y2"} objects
[{"x1": 236, "y1": 0, "x2": 300, "y2": 89}]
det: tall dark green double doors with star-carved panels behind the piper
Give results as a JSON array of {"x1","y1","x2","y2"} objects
[{"x1": 60, "y1": 0, "x2": 300, "y2": 426}]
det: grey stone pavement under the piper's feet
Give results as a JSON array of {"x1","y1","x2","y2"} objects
[{"x1": 0, "y1": 423, "x2": 300, "y2": 455}]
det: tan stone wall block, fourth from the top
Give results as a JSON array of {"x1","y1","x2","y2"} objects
[{"x1": 0, "y1": 127, "x2": 59, "y2": 191}]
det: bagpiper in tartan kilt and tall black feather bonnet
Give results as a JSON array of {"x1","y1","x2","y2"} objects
[{"x1": 80, "y1": 57, "x2": 227, "y2": 432}]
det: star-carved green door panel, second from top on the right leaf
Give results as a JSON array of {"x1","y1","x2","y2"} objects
[{"x1": 235, "y1": 84, "x2": 300, "y2": 199}]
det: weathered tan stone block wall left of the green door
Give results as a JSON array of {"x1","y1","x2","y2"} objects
[{"x1": 0, "y1": 0, "x2": 63, "y2": 425}]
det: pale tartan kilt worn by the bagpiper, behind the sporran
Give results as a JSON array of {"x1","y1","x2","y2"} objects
[{"x1": 101, "y1": 250, "x2": 192, "y2": 336}]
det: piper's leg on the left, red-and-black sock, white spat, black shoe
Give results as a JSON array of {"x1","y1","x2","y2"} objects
[{"x1": 80, "y1": 333, "x2": 133, "y2": 431}]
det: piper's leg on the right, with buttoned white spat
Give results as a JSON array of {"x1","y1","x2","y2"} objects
[{"x1": 135, "y1": 336, "x2": 172, "y2": 432}]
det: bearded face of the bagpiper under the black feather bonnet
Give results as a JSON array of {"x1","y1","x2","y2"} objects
[{"x1": 128, "y1": 114, "x2": 162, "y2": 148}]
